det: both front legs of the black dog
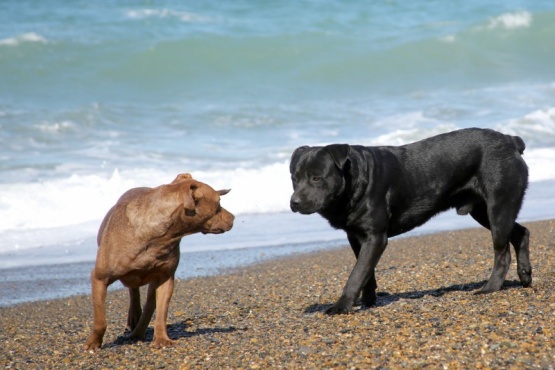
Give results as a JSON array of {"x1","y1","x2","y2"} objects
[{"x1": 326, "y1": 234, "x2": 387, "y2": 315}]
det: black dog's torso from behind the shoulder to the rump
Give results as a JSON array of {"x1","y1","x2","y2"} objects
[{"x1": 376, "y1": 129, "x2": 528, "y2": 236}]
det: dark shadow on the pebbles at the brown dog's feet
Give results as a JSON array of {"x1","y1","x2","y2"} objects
[{"x1": 103, "y1": 321, "x2": 246, "y2": 348}]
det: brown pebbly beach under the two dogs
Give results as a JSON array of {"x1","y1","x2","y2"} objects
[{"x1": 0, "y1": 220, "x2": 555, "y2": 369}]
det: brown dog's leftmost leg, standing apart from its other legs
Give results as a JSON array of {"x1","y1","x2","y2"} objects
[{"x1": 83, "y1": 269, "x2": 108, "y2": 350}]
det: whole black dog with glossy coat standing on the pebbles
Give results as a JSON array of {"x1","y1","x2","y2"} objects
[{"x1": 290, "y1": 128, "x2": 532, "y2": 314}]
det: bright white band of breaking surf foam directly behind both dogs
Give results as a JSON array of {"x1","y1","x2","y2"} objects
[{"x1": 0, "y1": 141, "x2": 555, "y2": 232}]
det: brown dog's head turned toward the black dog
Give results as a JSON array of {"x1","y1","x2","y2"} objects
[{"x1": 171, "y1": 173, "x2": 235, "y2": 234}]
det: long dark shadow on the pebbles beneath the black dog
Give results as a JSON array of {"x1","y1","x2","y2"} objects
[{"x1": 304, "y1": 280, "x2": 522, "y2": 314}]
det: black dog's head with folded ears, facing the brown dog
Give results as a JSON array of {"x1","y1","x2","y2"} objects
[{"x1": 289, "y1": 144, "x2": 350, "y2": 214}]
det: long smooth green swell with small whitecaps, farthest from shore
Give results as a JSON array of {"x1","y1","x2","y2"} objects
[{"x1": 0, "y1": 9, "x2": 555, "y2": 101}]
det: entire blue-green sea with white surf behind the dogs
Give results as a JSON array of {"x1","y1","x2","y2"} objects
[{"x1": 0, "y1": 0, "x2": 555, "y2": 304}]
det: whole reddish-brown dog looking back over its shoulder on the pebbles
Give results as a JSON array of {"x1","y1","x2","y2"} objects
[{"x1": 83, "y1": 173, "x2": 234, "y2": 349}]
